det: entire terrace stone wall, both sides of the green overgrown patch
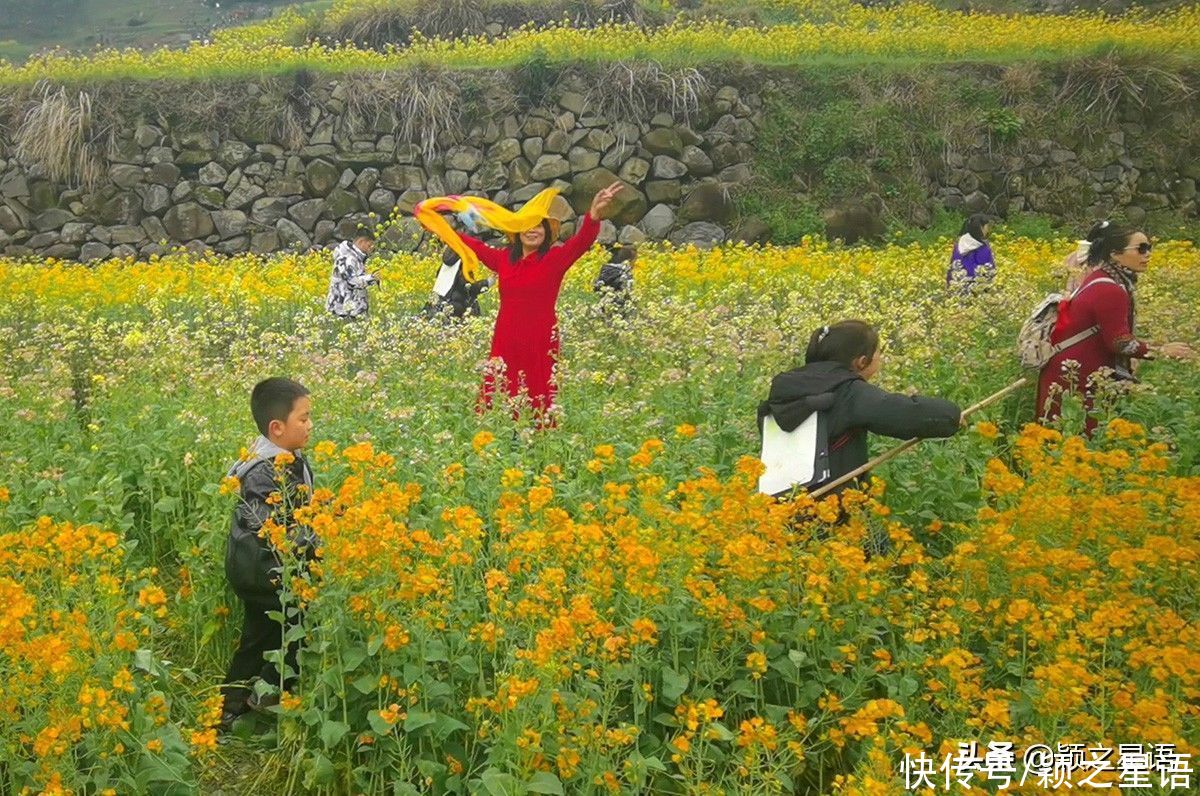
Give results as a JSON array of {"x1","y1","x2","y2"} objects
[{"x1": 0, "y1": 69, "x2": 1200, "y2": 262}]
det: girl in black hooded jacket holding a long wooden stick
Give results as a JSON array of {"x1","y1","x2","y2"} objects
[{"x1": 758, "y1": 321, "x2": 962, "y2": 499}]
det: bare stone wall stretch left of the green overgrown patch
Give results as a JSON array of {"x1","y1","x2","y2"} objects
[{"x1": 0, "y1": 77, "x2": 761, "y2": 262}]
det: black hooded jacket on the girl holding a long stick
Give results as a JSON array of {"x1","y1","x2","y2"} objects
[{"x1": 758, "y1": 363, "x2": 962, "y2": 489}]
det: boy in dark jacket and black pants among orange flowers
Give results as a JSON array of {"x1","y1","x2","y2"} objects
[{"x1": 221, "y1": 378, "x2": 319, "y2": 728}]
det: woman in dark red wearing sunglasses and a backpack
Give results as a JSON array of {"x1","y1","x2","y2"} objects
[{"x1": 1038, "y1": 221, "x2": 1193, "y2": 436}]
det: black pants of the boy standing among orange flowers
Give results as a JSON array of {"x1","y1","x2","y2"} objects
[{"x1": 221, "y1": 594, "x2": 300, "y2": 716}]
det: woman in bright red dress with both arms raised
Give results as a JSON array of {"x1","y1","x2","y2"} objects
[{"x1": 461, "y1": 182, "x2": 623, "y2": 426}]
